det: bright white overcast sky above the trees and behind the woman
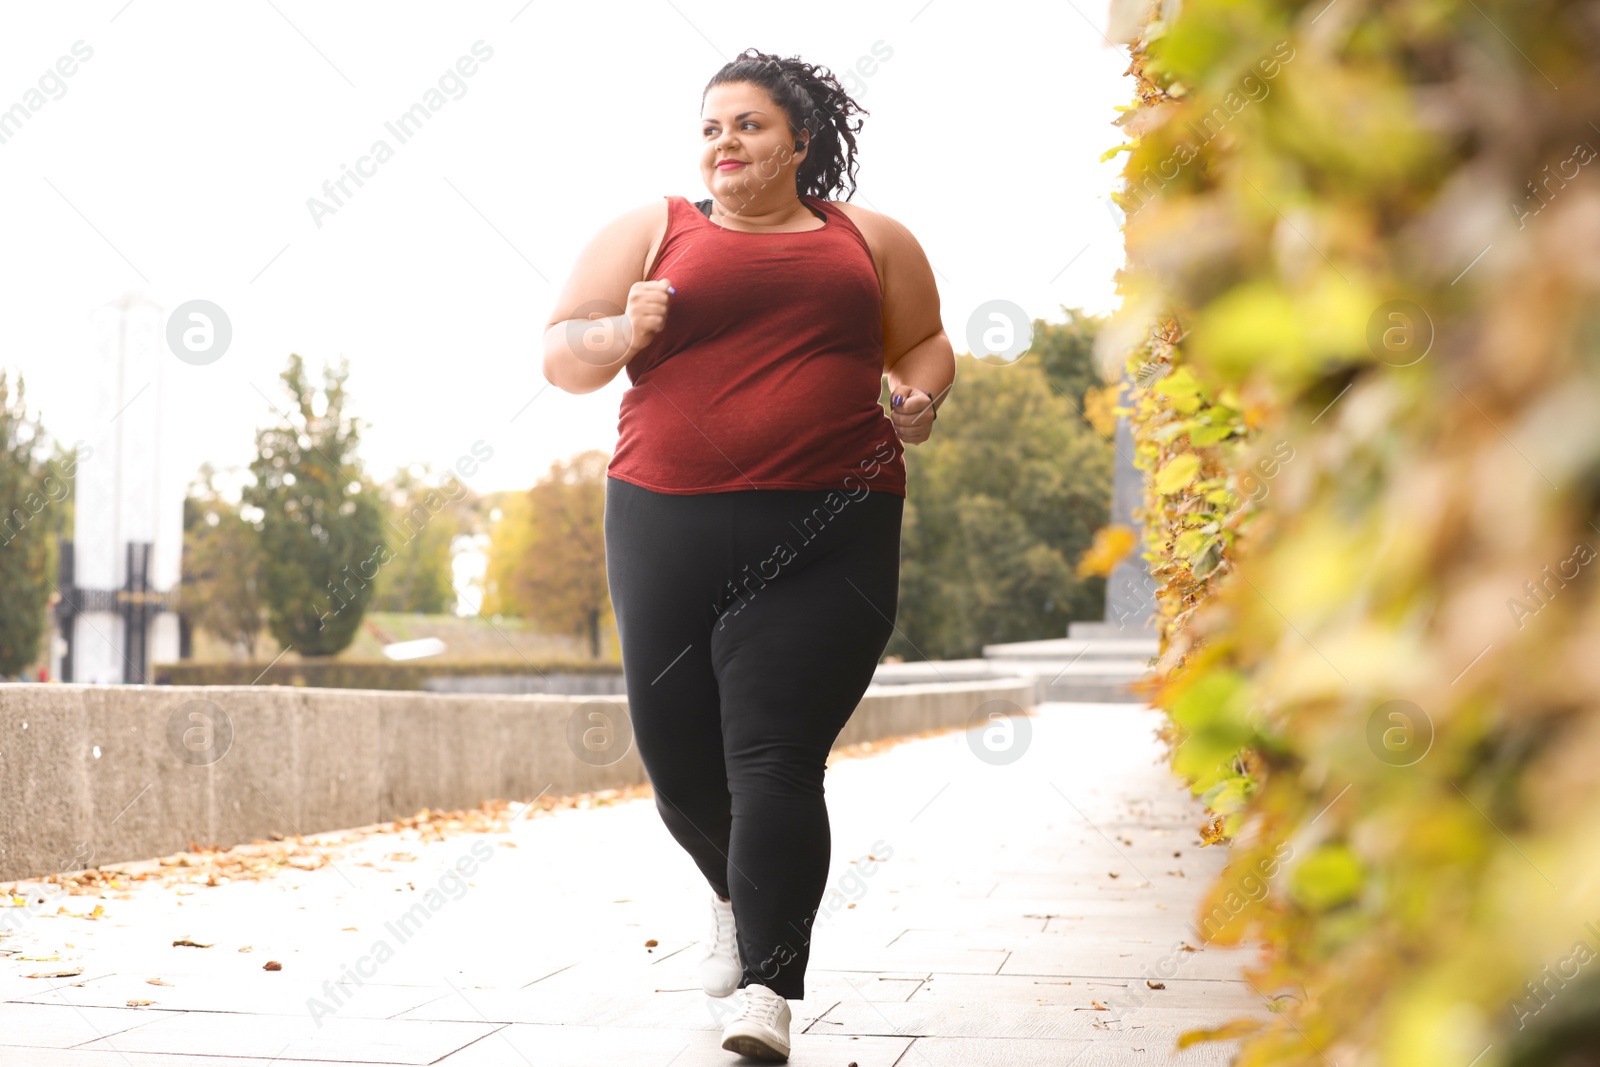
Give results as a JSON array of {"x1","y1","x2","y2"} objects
[{"x1": 0, "y1": 0, "x2": 1131, "y2": 502}]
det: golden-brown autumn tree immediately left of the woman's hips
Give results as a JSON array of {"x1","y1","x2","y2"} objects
[{"x1": 485, "y1": 451, "x2": 611, "y2": 657}]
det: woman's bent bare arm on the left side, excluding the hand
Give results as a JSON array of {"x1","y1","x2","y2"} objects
[{"x1": 544, "y1": 198, "x2": 667, "y2": 394}]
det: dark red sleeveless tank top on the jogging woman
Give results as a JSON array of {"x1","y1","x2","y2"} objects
[{"x1": 606, "y1": 197, "x2": 906, "y2": 496}]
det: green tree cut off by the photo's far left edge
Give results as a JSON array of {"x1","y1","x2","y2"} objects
[{"x1": 0, "y1": 371, "x2": 59, "y2": 677}]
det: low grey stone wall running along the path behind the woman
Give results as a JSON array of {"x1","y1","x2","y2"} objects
[{"x1": 0, "y1": 678, "x2": 1034, "y2": 880}]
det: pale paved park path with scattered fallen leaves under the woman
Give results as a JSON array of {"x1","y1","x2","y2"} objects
[{"x1": 0, "y1": 704, "x2": 1266, "y2": 1067}]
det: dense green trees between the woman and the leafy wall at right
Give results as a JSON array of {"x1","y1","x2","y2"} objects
[{"x1": 885, "y1": 312, "x2": 1112, "y2": 659}]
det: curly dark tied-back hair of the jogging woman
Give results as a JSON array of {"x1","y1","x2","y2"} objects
[{"x1": 701, "y1": 48, "x2": 872, "y2": 200}]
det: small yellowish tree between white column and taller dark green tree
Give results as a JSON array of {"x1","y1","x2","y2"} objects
[{"x1": 181, "y1": 464, "x2": 262, "y2": 659}]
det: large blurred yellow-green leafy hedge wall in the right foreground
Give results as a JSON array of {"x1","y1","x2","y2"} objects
[{"x1": 1096, "y1": 0, "x2": 1600, "y2": 1067}]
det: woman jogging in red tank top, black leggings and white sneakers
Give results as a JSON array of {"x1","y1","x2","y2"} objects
[{"x1": 544, "y1": 50, "x2": 955, "y2": 1059}]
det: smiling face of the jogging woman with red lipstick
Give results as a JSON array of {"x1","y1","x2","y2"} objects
[{"x1": 701, "y1": 82, "x2": 810, "y2": 214}]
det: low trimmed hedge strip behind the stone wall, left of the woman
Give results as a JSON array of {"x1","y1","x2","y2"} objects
[{"x1": 154, "y1": 659, "x2": 622, "y2": 689}]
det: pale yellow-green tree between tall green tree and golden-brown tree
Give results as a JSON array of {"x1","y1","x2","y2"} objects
[{"x1": 371, "y1": 466, "x2": 474, "y2": 614}]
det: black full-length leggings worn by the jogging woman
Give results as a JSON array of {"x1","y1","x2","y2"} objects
[{"x1": 605, "y1": 477, "x2": 904, "y2": 1000}]
